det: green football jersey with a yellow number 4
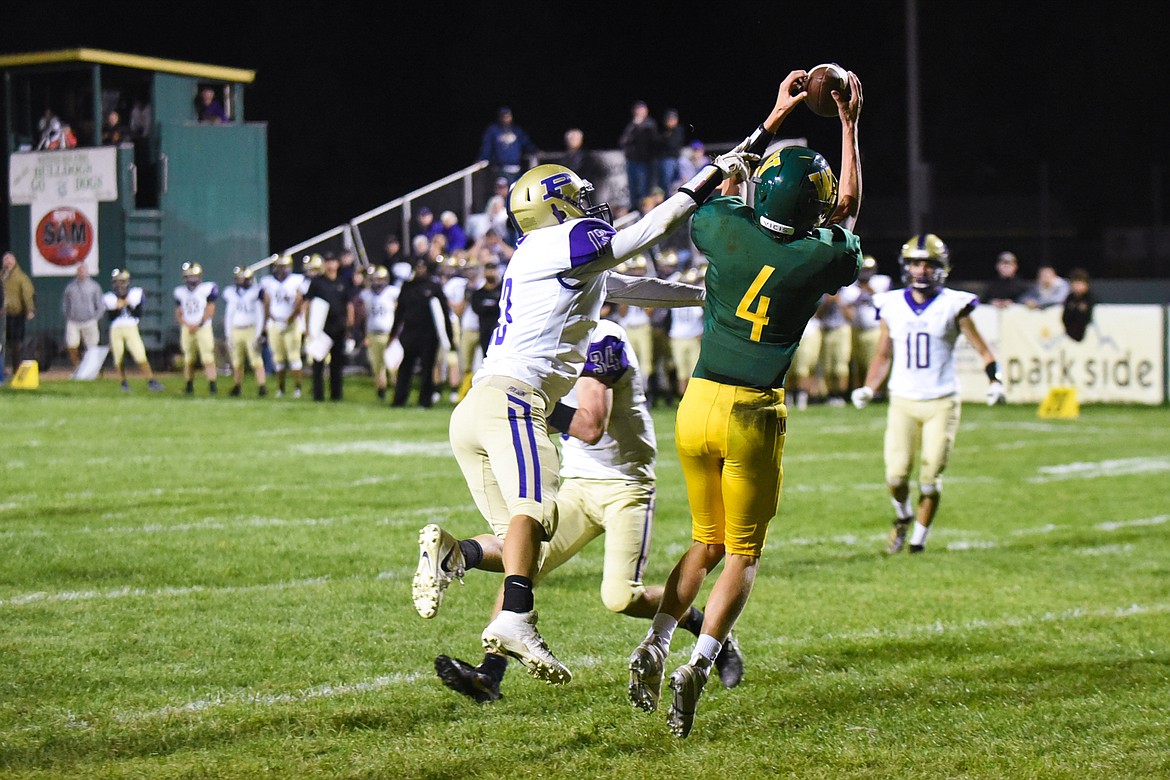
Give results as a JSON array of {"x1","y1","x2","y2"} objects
[{"x1": 690, "y1": 198, "x2": 861, "y2": 388}]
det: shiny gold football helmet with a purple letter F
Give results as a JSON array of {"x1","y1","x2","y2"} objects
[{"x1": 508, "y1": 165, "x2": 613, "y2": 235}]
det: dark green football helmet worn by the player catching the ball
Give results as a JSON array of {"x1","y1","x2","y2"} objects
[{"x1": 751, "y1": 146, "x2": 837, "y2": 236}]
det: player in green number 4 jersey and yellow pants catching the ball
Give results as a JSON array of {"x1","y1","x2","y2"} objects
[{"x1": 629, "y1": 70, "x2": 862, "y2": 737}]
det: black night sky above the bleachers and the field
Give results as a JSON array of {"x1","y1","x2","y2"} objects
[{"x1": 0, "y1": 0, "x2": 1170, "y2": 266}]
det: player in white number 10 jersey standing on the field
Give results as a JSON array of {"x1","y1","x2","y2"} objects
[{"x1": 853, "y1": 233, "x2": 1005, "y2": 554}]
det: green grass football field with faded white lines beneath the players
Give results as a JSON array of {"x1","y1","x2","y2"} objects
[{"x1": 0, "y1": 375, "x2": 1170, "y2": 779}]
